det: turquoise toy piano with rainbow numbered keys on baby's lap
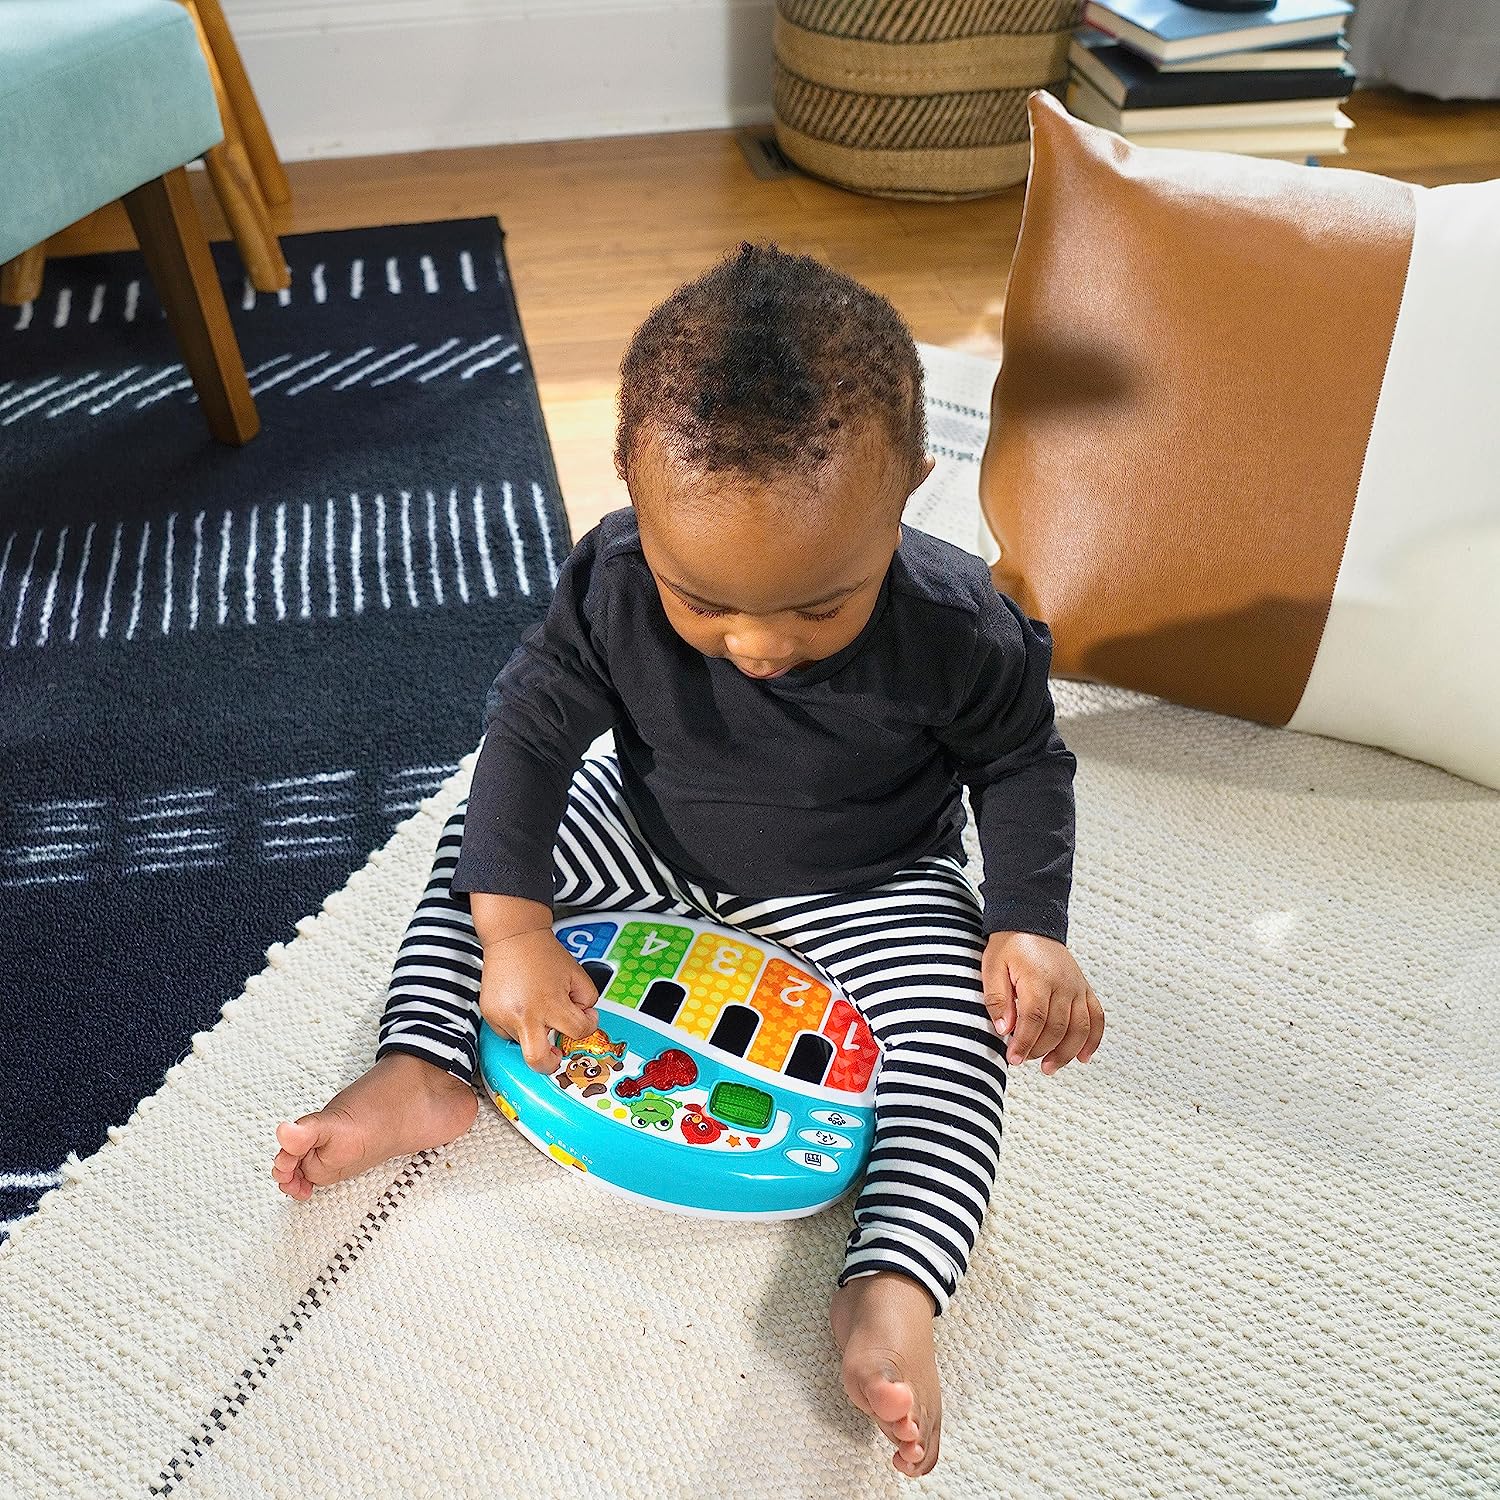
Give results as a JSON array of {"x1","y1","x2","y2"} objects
[{"x1": 479, "y1": 912, "x2": 878, "y2": 1218}]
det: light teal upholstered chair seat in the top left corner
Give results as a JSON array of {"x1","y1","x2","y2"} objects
[{"x1": 0, "y1": 0, "x2": 224, "y2": 261}]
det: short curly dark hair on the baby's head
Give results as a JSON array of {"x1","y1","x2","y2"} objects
[{"x1": 615, "y1": 242, "x2": 927, "y2": 482}]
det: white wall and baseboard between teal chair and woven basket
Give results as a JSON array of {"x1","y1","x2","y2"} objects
[{"x1": 225, "y1": 0, "x2": 773, "y2": 161}]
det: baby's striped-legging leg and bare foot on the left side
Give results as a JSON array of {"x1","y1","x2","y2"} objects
[{"x1": 272, "y1": 758, "x2": 692, "y2": 1199}]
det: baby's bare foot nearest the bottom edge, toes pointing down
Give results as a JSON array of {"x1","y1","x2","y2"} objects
[{"x1": 830, "y1": 1271, "x2": 942, "y2": 1476}]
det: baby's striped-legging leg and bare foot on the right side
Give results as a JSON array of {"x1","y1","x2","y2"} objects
[{"x1": 720, "y1": 860, "x2": 1005, "y2": 1475}]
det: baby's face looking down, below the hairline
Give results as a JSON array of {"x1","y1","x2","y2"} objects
[{"x1": 630, "y1": 432, "x2": 933, "y2": 678}]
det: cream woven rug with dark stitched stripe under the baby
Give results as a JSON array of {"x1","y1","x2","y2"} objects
[{"x1": 0, "y1": 345, "x2": 1500, "y2": 1500}]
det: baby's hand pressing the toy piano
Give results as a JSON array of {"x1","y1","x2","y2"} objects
[{"x1": 479, "y1": 927, "x2": 599, "y2": 1073}]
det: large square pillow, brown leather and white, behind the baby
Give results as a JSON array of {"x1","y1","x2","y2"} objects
[{"x1": 981, "y1": 95, "x2": 1500, "y2": 786}]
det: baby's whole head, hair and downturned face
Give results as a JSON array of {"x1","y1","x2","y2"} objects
[{"x1": 615, "y1": 245, "x2": 932, "y2": 678}]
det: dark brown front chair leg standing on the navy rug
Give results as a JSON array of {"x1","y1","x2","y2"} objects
[{"x1": 125, "y1": 167, "x2": 261, "y2": 444}]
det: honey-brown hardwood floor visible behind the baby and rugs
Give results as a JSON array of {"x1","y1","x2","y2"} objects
[{"x1": 51, "y1": 90, "x2": 1500, "y2": 533}]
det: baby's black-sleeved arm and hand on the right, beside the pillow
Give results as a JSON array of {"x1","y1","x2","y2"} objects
[{"x1": 939, "y1": 594, "x2": 1104, "y2": 1074}]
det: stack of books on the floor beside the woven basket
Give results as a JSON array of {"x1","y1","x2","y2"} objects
[{"x1": 1068, "y1": 0, "x2": 1355, "y2": 161}]
